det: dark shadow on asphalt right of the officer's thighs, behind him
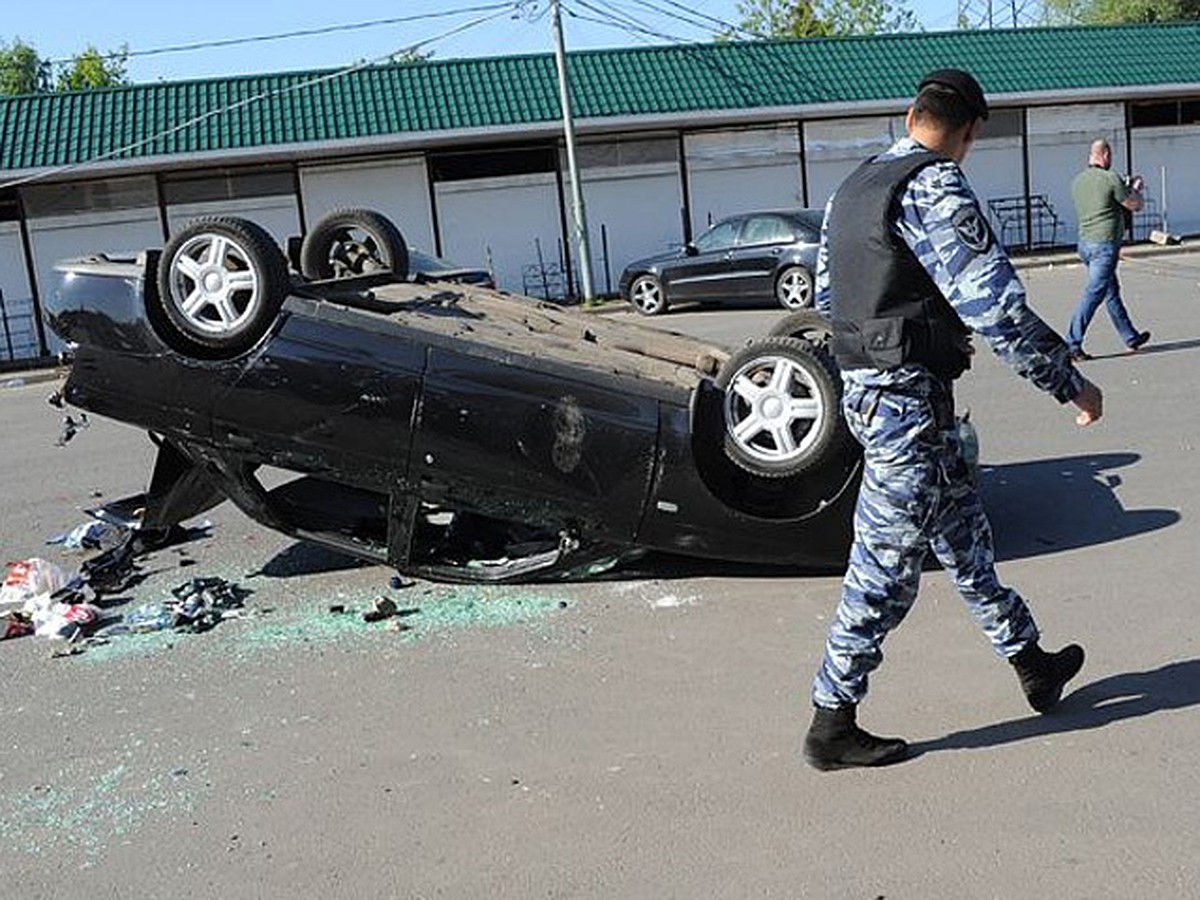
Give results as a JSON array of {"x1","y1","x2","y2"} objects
[{"x1": 980, "y1": 452, "x2": 1180, "y2": 560}]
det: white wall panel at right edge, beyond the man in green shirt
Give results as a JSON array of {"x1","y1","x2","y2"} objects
[{"x1": 1133, "y1": 125, "x2": 1200, "y2": 236}]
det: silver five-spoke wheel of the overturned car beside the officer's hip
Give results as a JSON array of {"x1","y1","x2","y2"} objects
[{"x1": 716, "y1": 337, "x2": 847, "y2": 478}]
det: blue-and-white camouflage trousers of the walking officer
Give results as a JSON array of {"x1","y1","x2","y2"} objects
[{"x1": 812, "y1": 374, "x2": 1038, "y2": 708}]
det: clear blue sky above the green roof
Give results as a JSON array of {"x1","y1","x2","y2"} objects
[{"x1": 0, "y1": 0, "x2": 964, "y2": 83}]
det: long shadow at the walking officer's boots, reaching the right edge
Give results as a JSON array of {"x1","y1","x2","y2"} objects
[{"x1": 910, "y1": 659, "x2": 1200, "y2": 758}]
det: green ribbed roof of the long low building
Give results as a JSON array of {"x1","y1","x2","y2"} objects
[{"x1": 0, "y1": 23, "x2": 1200, "y2": 170}]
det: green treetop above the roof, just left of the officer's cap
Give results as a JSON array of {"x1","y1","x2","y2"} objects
[{"x1": 738, "y1": 0, "x2": 916, "y2": 37}]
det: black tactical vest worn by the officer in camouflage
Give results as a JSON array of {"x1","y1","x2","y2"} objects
[{"x1": 827, "y1": 150, "x2": 971, "y2": 379}]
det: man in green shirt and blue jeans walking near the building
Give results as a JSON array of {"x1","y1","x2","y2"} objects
[{"x1": 1067, "y1": 139, "x2": 1150, "y2": 360}]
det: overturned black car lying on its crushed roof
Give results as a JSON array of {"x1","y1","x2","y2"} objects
[{"x1": 46, "y1": 210, "x2": 859, "y2": 581}]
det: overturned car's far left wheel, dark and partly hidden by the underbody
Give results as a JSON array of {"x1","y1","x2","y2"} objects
[{"x1": 300, "y1": 209, "x2": 408, "y2": 281}]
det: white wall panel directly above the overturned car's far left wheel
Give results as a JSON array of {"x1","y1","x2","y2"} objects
[{"x1": 300, "y1": 157, "x2": 434, "y2": 253}]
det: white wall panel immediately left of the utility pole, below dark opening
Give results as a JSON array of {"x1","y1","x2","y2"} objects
[{"x1": 434, "y1": 173, "x2": 562, "y2": 300}]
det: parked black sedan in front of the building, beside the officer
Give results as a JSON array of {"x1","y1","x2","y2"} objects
[{"x1": 620, "y1": 209, "x2": 824, "y2": 316}]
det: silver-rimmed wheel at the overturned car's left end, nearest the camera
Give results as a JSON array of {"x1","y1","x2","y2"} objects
[{"x1": 157, "y1": 216, "x2": 290, "y2": 355}]
